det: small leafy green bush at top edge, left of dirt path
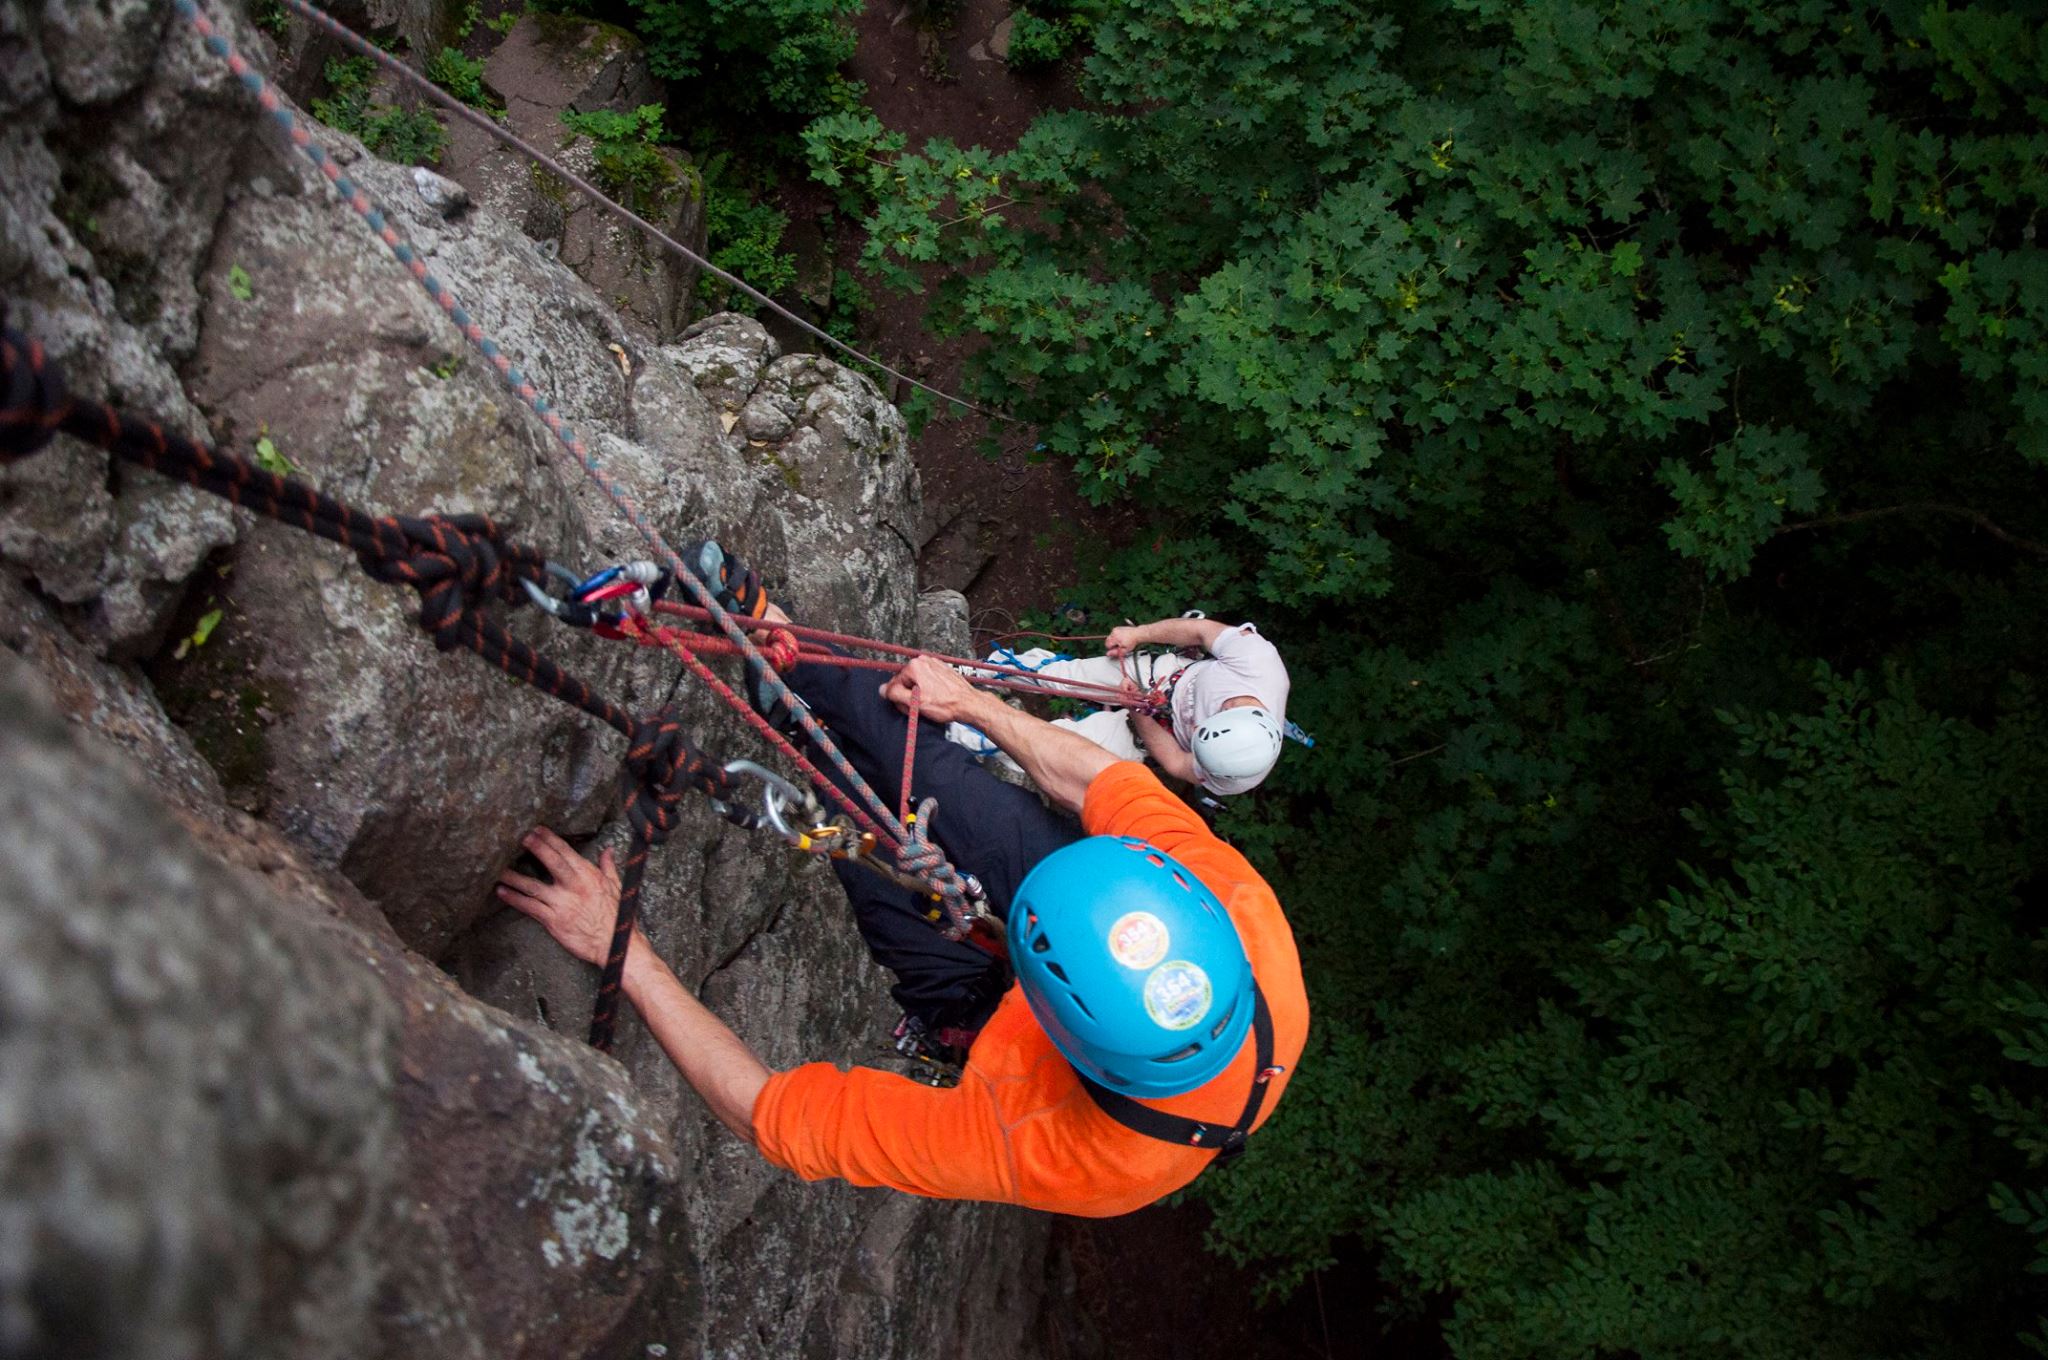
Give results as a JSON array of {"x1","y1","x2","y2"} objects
[{"x1": 627, "y1": 0, "x2": 862, "y2": 117}]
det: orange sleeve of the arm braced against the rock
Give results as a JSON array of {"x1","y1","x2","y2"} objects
[{"x1": 754, "y1": 1063, "x2": 1016, "y2": 1200}]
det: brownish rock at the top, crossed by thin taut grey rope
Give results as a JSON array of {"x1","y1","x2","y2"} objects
[{"x1": 440, "y1": 14, "x2": 705, "y2": 340}]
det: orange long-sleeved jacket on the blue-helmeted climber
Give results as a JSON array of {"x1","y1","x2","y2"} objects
[{"x1": 754, "y1": 762, "x2": 1309, "y2": 1219}]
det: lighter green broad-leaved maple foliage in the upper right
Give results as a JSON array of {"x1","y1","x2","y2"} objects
[{"x1": 831, "y1": 0, "x2": 2048, "y2": 598}]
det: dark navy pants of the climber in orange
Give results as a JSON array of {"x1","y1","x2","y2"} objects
[{"x1": 784, "y1": 664, "x2": 1081, "y2": 1030}]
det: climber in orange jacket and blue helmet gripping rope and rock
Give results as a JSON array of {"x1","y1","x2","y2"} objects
[{"x1": 500, "y1": 557, "x2": 1309, "y2": 1217}]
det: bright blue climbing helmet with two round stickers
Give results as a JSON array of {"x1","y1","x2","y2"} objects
[{"x1": 1010, "y1": 836, "x2": 1253, "y2": 1098}]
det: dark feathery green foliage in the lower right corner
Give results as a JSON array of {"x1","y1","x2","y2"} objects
[{"x1": 1384, "y1": 674, "x2": 2048, "y2": 1358}]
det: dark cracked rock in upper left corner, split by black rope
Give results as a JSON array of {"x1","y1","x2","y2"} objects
[{"x1": 0, "y1": 0, "x2": 248, "y2": 655}]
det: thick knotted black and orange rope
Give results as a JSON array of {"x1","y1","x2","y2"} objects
[{"x1": 0, "y1": 328, "x2": 745, "y2": 1051}]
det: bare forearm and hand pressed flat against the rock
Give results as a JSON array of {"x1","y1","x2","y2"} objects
[{"x1": 498, "y1": 827, "x2": 770, "y2": 1145}]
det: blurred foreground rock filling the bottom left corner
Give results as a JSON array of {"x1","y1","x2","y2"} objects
[{"x1": 0, "y1": 655, "x2": 688, "y2": 1360}]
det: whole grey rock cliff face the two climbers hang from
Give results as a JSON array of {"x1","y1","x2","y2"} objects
[{"x1": 0, "y1": 0, "x2": 1044, "y2": 1360}]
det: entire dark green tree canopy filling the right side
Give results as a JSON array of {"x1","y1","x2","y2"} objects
[{"x1": 805, "y1": 0, "x2": 2048, "y2": 1356}]
